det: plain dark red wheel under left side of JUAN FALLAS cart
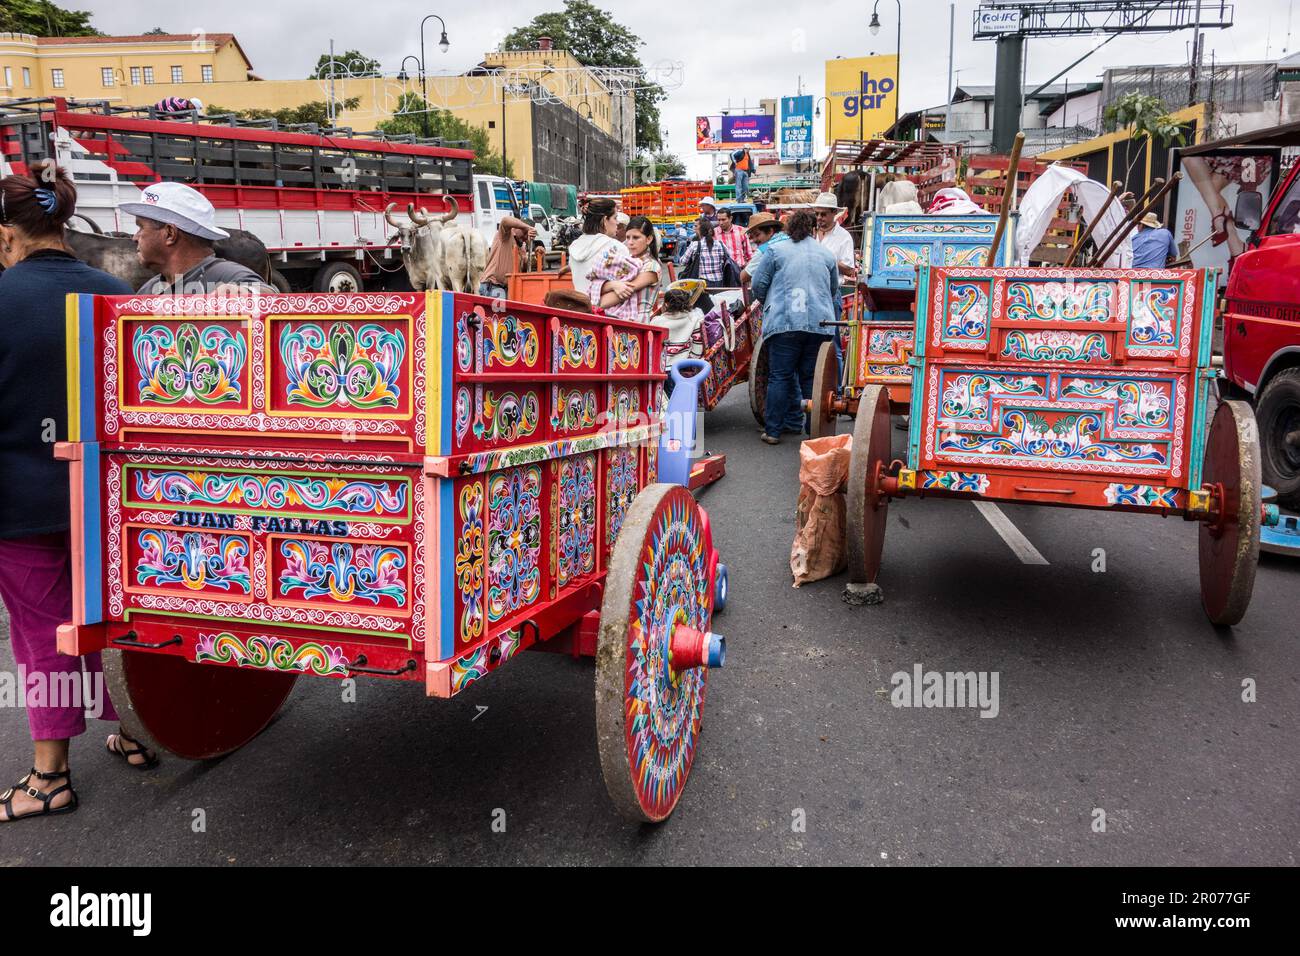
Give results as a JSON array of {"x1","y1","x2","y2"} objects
[{"x1": 104, "y1": 649, "x2": 298, "y2": 760}]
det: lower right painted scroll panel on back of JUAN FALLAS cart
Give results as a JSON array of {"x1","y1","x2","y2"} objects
[{"x1": 280, "y1": 538, "x2": 407, "y2": 607}]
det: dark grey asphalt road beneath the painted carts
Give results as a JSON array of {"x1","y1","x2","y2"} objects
[{"x1": 0, "y1": 389, "x2": 1300, "y2": 865}]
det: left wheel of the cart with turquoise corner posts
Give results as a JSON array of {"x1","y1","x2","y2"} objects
[{"x1": 848, "y1": 385, "x2": 891, "y2": 584}]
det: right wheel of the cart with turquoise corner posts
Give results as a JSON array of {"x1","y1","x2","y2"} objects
[{"x1": 1200, "y1": 401, "x2": 1262, "y2": 626}]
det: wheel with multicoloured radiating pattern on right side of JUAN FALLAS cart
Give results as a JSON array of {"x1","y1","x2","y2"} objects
[{"x1": 595, "y1": 484, "x2": 724, "y2": 822}]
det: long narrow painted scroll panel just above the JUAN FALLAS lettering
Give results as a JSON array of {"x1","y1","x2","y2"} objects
[{"x1": 133, "y1": 468, "x2": 408, "y2": 515}]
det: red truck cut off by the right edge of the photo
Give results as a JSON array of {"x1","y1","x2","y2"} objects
[{"x1": 1223, "y1": 157, "x2": 1300, "y2": 509}]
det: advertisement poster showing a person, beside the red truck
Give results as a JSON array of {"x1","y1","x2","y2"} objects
[{"x1": 1165, "y1": 146, "x2": 1282, "y2": 285}]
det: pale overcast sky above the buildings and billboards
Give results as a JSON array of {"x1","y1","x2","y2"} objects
[{"x1": 86, "y1": 0, "x2": 1300, "y2": 174}]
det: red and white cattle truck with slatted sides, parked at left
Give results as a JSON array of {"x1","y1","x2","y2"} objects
[{"x1": 0, "y1": 98, "x2": 520, "y2": 293}]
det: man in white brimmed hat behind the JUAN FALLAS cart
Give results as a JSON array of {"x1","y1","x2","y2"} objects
[{"x1": 118, "y1": 182, "x2": 265, "y2": 295}]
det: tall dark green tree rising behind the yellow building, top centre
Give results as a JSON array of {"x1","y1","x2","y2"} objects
[{"x1": 501, "y1": 0, "x2": 668, "y2": 150}]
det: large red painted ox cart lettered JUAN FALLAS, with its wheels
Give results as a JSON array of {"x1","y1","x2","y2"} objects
[{"x1": 59, "y1": 293, "x2": 725, "y2": 821}]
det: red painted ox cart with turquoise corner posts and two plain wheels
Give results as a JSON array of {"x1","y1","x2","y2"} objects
[{"x1": 848, "y1": 268, "x2": 1278, "y2": 624}]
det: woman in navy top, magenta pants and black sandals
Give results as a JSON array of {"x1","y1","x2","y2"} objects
[{"x1": 0, "y1": 160, "x2": 157, "y2": 823}]
